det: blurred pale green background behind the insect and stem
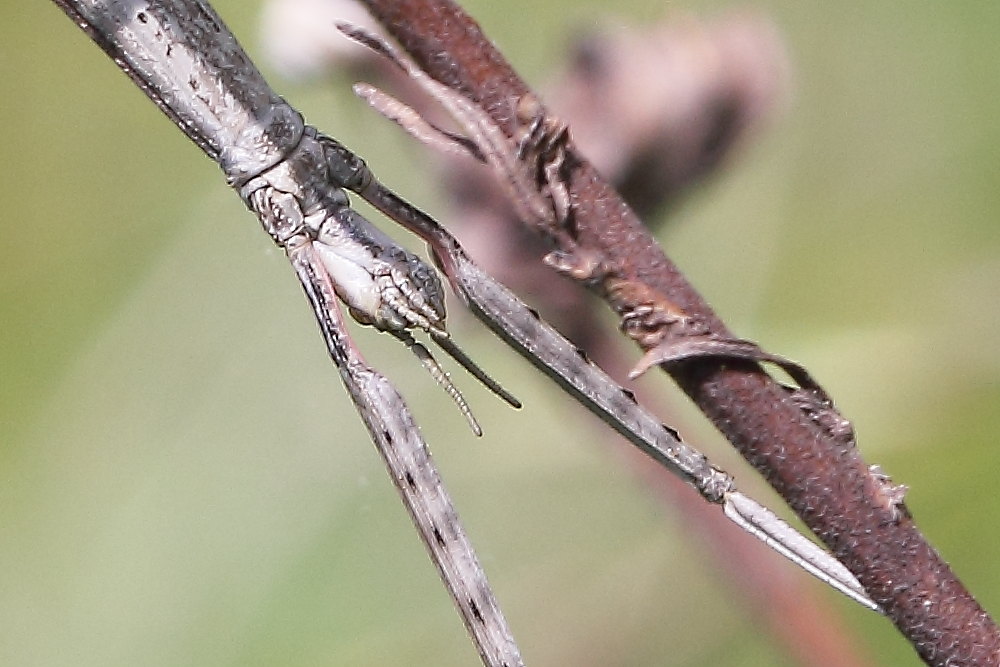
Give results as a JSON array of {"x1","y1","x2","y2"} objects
[{"x1": 0, "y1": 0, "x2": 1000, "y2": 665}]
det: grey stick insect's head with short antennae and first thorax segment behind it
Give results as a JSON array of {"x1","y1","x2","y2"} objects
[{"x1": 241, "y1": 127, "x2": 520, "y2": 435}]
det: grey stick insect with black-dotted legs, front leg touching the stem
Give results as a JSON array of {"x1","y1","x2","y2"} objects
[{"x1": 54, "y1": 0, "x2": 877, "y2": 665}]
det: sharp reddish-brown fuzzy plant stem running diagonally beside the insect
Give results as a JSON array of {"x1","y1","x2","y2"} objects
[{"x1": 365, "y1": 0, "x2": 1000, "y2": 665}]
